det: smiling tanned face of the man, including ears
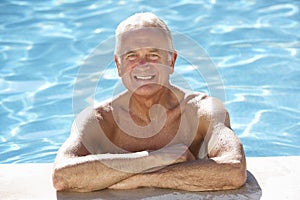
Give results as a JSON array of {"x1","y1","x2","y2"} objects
[{"x1": 115, "y1": 28, "x2": 177, "y2": 96}]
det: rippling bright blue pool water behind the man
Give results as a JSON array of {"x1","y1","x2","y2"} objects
[{"x1": 0, "y1": 0, "x2": 300, "y2": 163}]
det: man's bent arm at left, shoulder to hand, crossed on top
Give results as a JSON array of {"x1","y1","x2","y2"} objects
[{"x1": 53, "y1": 109, "x2": 187, "y2": 192}]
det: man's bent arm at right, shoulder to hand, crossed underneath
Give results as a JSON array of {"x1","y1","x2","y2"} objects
[{"x1": 110, "y1": 98, "x2": 246, "y2": 191}]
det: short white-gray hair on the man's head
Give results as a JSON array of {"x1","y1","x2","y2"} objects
[{"x1": 115, "y1": 12, "x2": 174, "y2": 57}]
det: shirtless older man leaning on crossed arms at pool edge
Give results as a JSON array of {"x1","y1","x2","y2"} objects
[{"x1": 53, "y1": 13, "x2": 246, "y2": 192}]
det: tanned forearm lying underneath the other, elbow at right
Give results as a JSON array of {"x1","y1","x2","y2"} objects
[{"x1": 111, "y1": 159, "x2": 246, "y2": 191}]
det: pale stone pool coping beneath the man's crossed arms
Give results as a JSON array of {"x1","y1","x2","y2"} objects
[{"x1": 0, "y1": 156, "x2": 300, "y2": 200}]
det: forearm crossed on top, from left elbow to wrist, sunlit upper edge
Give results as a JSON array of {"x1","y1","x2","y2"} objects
[{"x1": 53, "y1": 152, "x2": 156, "y2": 192}]
